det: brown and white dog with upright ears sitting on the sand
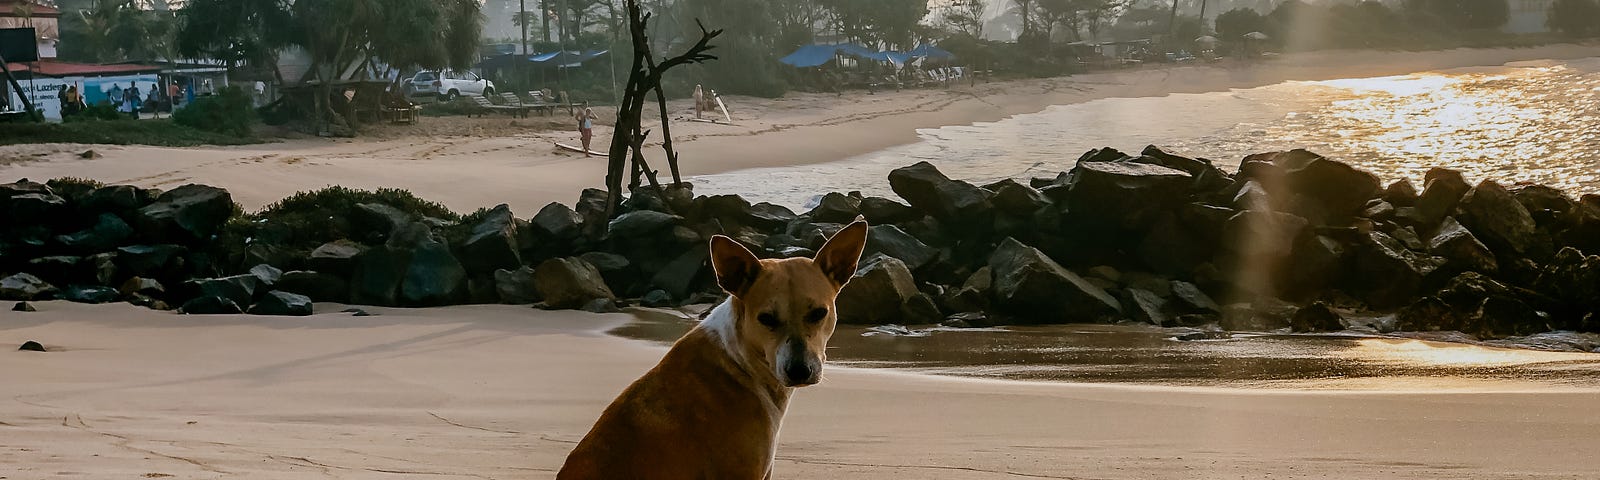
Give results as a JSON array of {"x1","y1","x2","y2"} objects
[{"x1": 555, "y1": 221, "x2": 867, "y2": 480}]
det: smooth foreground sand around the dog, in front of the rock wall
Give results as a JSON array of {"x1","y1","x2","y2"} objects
[{"x1": 0, "y1": 302, "x2": 1600, "y2": 478}]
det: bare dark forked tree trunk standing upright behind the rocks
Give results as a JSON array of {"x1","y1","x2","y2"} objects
[{"x1": 605, "y1": 0, "x2": 722, "y2": 218}]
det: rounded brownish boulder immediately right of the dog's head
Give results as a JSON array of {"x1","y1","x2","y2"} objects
[{"x1": 835, "y1": 254, "x2": 920, "y2": 325}]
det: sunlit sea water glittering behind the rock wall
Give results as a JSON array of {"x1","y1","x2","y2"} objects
[{"x1": 693, "y1": 58, "x2": 1600, "y2": 210}]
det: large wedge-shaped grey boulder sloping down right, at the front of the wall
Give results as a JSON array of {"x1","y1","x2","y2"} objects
[{"x1": 989, "y1": 238, "x2": 1122, "y2": 323}]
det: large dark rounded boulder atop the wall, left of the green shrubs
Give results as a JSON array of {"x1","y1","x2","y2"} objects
[{"x1": 134, "y1": 184, "x2": 234, "y2": 243}]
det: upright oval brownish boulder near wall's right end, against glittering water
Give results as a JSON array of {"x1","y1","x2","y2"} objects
[{"x1": 1459, "y1": 181, "x2": 1549, "y2": 256}]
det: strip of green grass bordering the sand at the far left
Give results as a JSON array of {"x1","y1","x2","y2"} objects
[{"x1": 0, "y1": 118, "x2": 262, "y2": 147}]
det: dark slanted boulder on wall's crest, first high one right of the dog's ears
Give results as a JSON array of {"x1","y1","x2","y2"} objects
[{"x1": 890, "y1": 162, "x2": 992, "y2": 221}]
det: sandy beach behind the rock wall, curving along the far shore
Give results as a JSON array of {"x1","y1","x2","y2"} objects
[{"x1": 0, "y1": 45, "x2": 1597, "y2": 214}]
